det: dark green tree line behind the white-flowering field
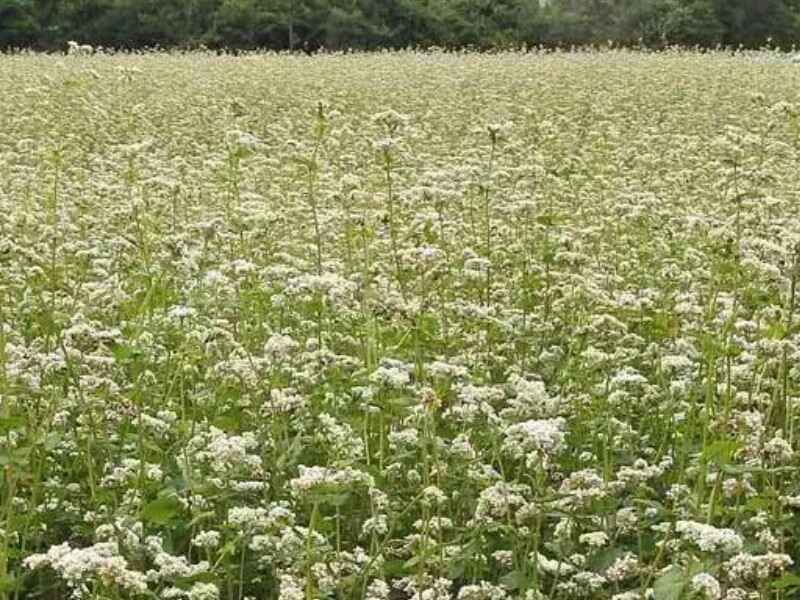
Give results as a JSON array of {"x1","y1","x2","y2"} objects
[{"x1": 0, "y1": 0, "x2": 800, "y2": 51}]
